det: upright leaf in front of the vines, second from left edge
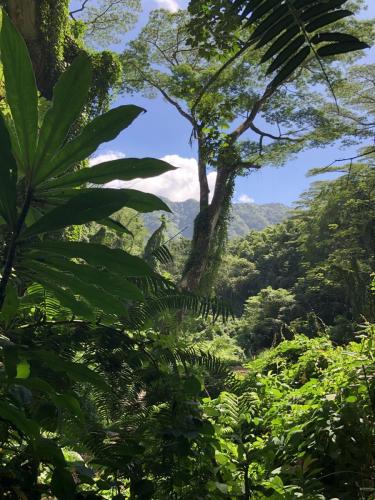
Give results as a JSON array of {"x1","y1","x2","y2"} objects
[{"x1": 35, "y1": 55, "x2": 92, "y2": 184}]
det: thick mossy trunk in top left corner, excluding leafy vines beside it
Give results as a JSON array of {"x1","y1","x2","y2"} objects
[{"x1": 6, "y1": 0, "x2": 69, "y2": 99}]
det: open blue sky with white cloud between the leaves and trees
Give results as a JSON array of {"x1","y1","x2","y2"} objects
[{"x1": 92, "y1": 0, "x2": 375, "y2": 205}]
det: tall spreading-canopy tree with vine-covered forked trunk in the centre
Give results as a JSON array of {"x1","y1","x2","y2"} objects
[{"x1": 123, "y1": 7, "x2": 374, "y2": 290}]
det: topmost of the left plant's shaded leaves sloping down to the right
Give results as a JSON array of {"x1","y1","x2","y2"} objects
[{"x1": 24, "y1": 241, "x2": 155, "y2": 277}]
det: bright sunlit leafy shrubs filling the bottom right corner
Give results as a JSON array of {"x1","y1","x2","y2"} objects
[{"x1": 204, "y1": 325, "x2": 375, "y2": 500}]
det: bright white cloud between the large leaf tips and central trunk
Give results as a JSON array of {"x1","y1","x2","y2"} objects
[{"x1": 90, "y1": 151, "x2": 217, "y2": 201}]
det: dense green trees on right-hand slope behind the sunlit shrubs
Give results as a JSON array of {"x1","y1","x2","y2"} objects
[{"x1": 215, "y1": 162, "x2": 375, "y2": 343}]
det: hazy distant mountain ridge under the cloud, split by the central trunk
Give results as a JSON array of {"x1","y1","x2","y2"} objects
[{"x1": 144, "y1": 199, "x2": 290, "y2": 239}]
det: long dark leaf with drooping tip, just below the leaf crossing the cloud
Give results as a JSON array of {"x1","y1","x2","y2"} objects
[{"x1": 22, "y1": 188, "x2": 170, "y2": 238}]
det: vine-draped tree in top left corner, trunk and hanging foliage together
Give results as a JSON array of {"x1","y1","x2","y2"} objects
[{"x1": 0, "y1": 0, "x2": 130, "y2": 111}]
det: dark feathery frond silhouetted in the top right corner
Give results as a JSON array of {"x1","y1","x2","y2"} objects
[{"x1": 244, "y1": 0, "x2": 368, "y2": 86}]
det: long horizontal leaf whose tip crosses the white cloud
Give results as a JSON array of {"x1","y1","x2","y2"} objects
[{"x1": 39, "y1": 158, "x2": 175, "y2": 191}]
